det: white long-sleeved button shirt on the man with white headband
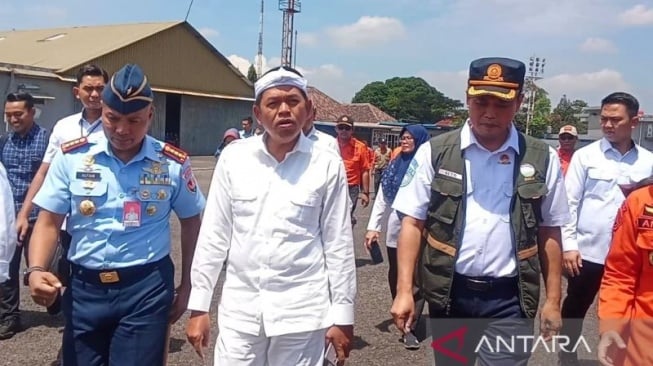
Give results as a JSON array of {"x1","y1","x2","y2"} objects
[{"x1": 188, "y1": 134, "x2": 356, "y2": 336}]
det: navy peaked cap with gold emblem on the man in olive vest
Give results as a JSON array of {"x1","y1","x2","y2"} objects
[{"x1": 467, "y1": 57, "x2": 526, "y2": 100}]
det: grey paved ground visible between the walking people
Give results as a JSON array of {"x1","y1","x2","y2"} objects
[{"x1": 0, "y1": 158, "x2": 597, "y2": 366}]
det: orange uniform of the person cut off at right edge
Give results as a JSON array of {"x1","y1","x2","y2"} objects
[{"x1": 598, "y1": 185, "x2": 653, "y2": 366}]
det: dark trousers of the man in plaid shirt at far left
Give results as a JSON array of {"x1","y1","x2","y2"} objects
[{"x1": 0, "y1": 225, "x2": 33, "y2": 320}]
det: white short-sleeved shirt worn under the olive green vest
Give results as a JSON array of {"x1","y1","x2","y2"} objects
[{"x1": 392, "y1": 123, "x2": 569, "y2": 277}]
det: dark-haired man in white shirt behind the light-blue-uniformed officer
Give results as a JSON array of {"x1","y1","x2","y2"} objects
[{"x1": 16, "y1": 65, "x2": 109, "y2": 294}]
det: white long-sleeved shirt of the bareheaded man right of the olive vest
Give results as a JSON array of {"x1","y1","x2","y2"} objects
[{"x1": 562, "y1": 138, "x2": 653, "y2": 264}]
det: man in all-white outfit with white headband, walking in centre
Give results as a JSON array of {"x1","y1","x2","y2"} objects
[{"x1": 186, "y1": 67, "x2": 356, "y2": 366}]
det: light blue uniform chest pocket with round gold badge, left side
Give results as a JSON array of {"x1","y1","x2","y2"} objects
[{"x1": 70, "y1": 181, "x2": 107, "y2": 227}]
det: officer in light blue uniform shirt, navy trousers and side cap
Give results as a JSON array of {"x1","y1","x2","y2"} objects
[{"x1": 25, "y1": 65, "x2": 205, "y2": 366}]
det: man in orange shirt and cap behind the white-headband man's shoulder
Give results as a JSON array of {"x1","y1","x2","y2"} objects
[{"x1": 336, "y1": 116, "x2": 372, "y2": 225}]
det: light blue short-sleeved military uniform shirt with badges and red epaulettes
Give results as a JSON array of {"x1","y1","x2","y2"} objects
[{"x1": 34, "y1": 136, "x2": 205, "y2": 269}]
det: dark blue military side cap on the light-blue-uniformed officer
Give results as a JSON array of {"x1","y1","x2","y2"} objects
[{"x1": 102, "y1": 64, "x2": 154, "y2": 114}]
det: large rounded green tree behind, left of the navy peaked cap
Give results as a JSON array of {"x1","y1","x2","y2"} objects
[{"x1": 352, "y1": 77, "x2": 463, "y2": 123}]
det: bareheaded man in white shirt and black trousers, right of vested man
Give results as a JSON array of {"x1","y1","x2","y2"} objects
[{"x1": 560, "y1": 92, "x2": 653, "y2": 365}]
